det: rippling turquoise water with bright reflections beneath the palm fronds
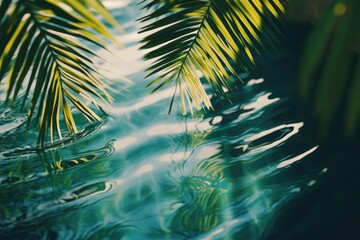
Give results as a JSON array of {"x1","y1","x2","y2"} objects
[{"x1": 0, "y1": 1, "x2": 334, "y2": 240}]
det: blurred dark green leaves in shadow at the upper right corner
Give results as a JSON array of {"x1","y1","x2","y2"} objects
[{"x1": 289, "y1": 0, "x2": 360, "y2": 139}]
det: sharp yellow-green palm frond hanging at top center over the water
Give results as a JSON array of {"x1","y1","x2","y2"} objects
[{"x1": 140, "y1": 0, "x2": 284, "y2": 114}]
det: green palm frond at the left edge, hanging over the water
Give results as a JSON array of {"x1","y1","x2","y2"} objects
[{"x1": 0, "y1": 0, "x2": 120, "y2": 143}]
